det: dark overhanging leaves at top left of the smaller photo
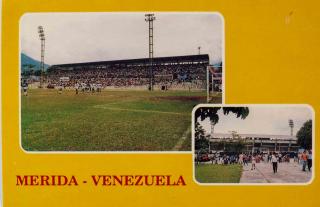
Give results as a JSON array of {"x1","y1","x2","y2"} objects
[{"x1": 195, "y1": 107, "x2": 249, "y2": 124}]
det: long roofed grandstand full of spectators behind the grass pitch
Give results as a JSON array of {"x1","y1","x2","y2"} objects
[{"x1": 46, "y1": 54, "x2": 209, "y2": 90}]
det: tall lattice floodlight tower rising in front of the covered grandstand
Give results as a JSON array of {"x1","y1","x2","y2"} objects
[{"x1": 145, "y1": 14, "x2": 156, "y2": 91}]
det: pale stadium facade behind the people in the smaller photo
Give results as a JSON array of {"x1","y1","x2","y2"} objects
[{"x1": 209, "y1": 133, "x2": 299, "y2": 153}]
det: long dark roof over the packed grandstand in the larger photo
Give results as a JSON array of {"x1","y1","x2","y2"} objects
[{"x1": 51, "y1": 54, "x2": 209, "y2": 68}]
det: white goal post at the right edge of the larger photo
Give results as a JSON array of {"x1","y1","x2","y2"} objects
[{"x1": 206, "y1": 65, "x2": 222, "y2": 103}]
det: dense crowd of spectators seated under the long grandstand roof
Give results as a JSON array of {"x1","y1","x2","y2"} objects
[{"x1": 46, "y1": 64, "x2": 206, "y2": 89}]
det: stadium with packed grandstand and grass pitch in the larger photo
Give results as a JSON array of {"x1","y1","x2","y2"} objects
[{"x1": 21, "y1": 13, "x2": 223, "y2": 151}]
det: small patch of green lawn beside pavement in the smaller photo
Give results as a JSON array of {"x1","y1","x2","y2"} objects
[{"x1": 195, "y1": 164, "x2": 242, "y2": 183}]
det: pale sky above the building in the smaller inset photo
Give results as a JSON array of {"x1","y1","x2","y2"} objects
[{"x1": 201, "y1": 105, "x2": 312, "y2": 135}]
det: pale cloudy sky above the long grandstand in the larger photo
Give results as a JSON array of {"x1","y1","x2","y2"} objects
[{"x1": 20, "y1": 13, "x2": 223, "y2": 65}]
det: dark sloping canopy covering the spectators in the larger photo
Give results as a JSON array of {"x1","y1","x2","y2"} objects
[{"x1": 48, "y1": 54, "x2": 209, "y2": 71}]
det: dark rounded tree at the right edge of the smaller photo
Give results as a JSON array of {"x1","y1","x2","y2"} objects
[{"x1": 297, "y1": 119, "x2": 312, "y2": 149}]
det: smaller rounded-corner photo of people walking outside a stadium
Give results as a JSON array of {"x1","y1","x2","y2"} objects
[{"x1": 193, "y1": 104, "x2": 314, "y2": 185}]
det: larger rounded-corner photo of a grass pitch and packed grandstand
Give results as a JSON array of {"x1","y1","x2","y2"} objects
[{"x1": 19, "y1": 12, "x2": 224, "y2": 152}]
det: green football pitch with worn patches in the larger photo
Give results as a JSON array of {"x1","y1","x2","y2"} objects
[{"x1": 21, "y1": 89, "x2": 221, "y2": 151}]
